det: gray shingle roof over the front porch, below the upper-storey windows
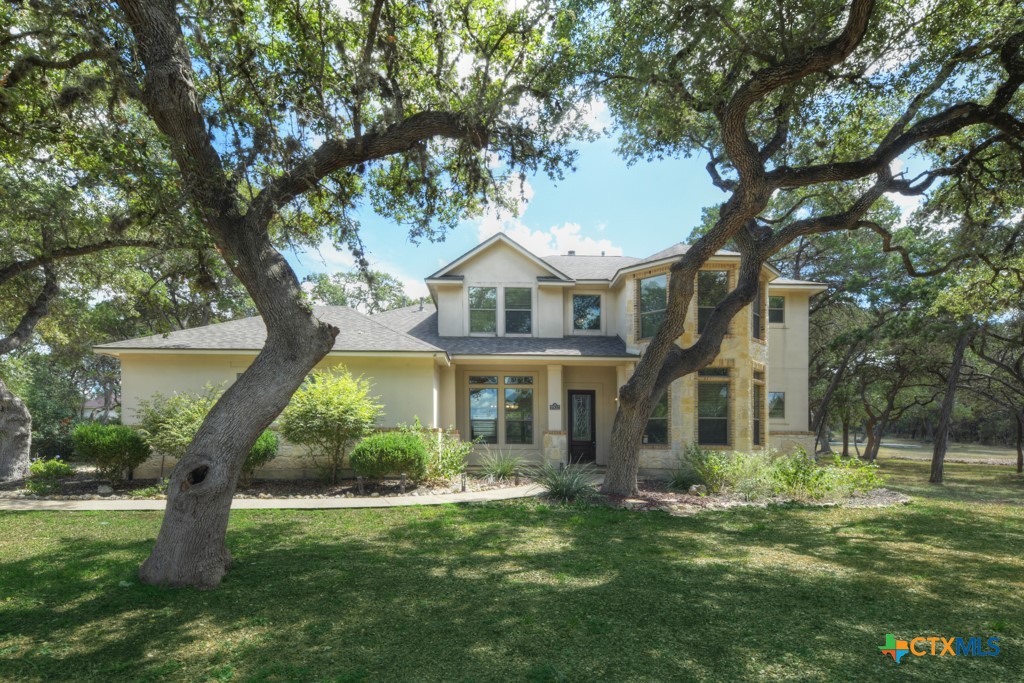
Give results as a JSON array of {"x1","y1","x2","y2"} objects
[{"x1": 373, "y1": 305, "x2": 636, "y2": 358}]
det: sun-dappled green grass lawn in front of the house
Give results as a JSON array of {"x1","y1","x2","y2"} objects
[{"x1": 0, "y1": 462, "x2": 1024, "y2": 682}]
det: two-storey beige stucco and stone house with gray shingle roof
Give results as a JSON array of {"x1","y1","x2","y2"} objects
[{"x1": 95, "y1": 233, "x2": 825, "y2": 476}]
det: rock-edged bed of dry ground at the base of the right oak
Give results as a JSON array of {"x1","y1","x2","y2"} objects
[{"x1": 597, "y1": 481, "x2": 910, "y2": 516}]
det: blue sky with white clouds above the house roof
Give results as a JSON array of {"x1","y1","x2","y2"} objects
[{"x1": 289, "y1": 107, "x2": 724, "y2": 296}]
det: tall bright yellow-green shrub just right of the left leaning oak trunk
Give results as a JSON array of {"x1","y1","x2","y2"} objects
[{"x1": 281, "y1": 369, "x2": 383, "y2": 483}]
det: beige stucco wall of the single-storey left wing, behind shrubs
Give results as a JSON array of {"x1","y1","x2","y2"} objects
[{"x1": 121, "y1": 353, "x2": 442, "y2": 478}]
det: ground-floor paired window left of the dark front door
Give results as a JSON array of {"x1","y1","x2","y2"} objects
[{"x1": 469, "y1": 375, "x2": 535, "y2": 444}]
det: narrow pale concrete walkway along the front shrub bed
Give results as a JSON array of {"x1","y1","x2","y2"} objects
[{"x1": 0, "y1": 484, "x2": 542, "y2": 511}]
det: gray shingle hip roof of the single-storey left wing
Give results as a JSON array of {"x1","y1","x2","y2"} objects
[{"x1": 94, "y1": 306, "x2": 441, "y2": 353}]
